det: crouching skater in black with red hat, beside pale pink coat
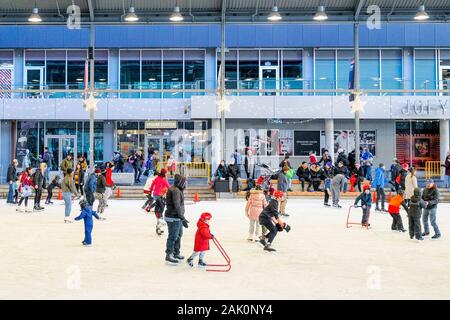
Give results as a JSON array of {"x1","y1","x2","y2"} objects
[{"x1": 259, "y1": 190, "x2": 285, "y2": 251}]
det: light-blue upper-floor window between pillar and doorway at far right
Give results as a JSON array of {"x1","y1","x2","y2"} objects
[{"x1": 414, "y1": 49, "x2": 436, "y2": 95}]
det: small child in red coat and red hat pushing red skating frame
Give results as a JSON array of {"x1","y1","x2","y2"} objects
[{"x1": 186, "y1": 212, "x2": 214, "y2": 267}]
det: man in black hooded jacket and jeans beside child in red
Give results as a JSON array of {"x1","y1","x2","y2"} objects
[{"x1": 165, "y1": 174, "x2": 188, "y2": 264}]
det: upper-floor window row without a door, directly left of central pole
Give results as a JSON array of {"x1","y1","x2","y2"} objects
[{"x1": 120, "y1": 50, "x2": 205, "y2": 99}]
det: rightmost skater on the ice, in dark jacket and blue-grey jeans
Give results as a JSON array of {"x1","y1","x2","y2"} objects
[{"x1": 422, "y1": 179, "x2": 441, "y2": 239}]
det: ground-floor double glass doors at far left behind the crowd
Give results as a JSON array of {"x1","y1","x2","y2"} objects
[{"x1": 44, "y1": 135, "x2": 78, "y2": 171}]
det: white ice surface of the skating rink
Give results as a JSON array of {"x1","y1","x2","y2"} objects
[{"x1": 0, "y1": 199, "x2": 450, "y2": 299}]
